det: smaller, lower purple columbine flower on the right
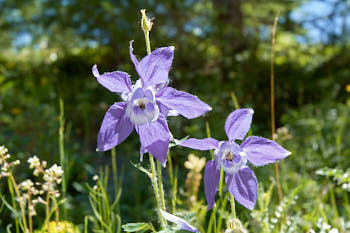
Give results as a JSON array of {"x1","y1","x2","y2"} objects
[{"x1": 177, "y1": 109, "x2": 291, "y2": 210}]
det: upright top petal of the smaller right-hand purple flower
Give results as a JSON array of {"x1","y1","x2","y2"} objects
[{"x1": 225, "y1": 108, "x2": 254, "y2": 141}]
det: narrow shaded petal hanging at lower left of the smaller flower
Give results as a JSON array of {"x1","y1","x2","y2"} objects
[{"x1": 204, "y1": 160, "x2": 220, "y2": 210}]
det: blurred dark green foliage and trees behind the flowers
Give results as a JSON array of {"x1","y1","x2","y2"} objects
[{"x1": 0, "y1": 0, "x2": 350, "y2": 232}]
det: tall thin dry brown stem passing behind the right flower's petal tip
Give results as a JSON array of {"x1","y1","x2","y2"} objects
[{"x1": 270, "y1": 13, "x2": 283, "y2": 201}]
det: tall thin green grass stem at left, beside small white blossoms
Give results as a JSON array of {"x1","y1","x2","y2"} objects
[{"x1": 58, "y1": 98, "x2": 67, "y2": 219}]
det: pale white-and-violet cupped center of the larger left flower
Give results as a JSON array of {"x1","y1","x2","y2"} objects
[{"x1": 126, "y1": 87, "x2": 159, "y2": 125}]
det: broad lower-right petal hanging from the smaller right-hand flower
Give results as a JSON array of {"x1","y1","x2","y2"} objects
[{"x1": 225, "y1": 166, "x2": 258, "y2": 210}]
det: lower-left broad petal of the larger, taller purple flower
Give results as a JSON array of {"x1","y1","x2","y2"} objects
[{"x1": 97, "y1": 102, "x2": 134, "y2": 151}]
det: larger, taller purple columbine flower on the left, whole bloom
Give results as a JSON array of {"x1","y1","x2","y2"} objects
[{"x1": 92, "y1": 42, "x2": 211, "y2": 165}]
